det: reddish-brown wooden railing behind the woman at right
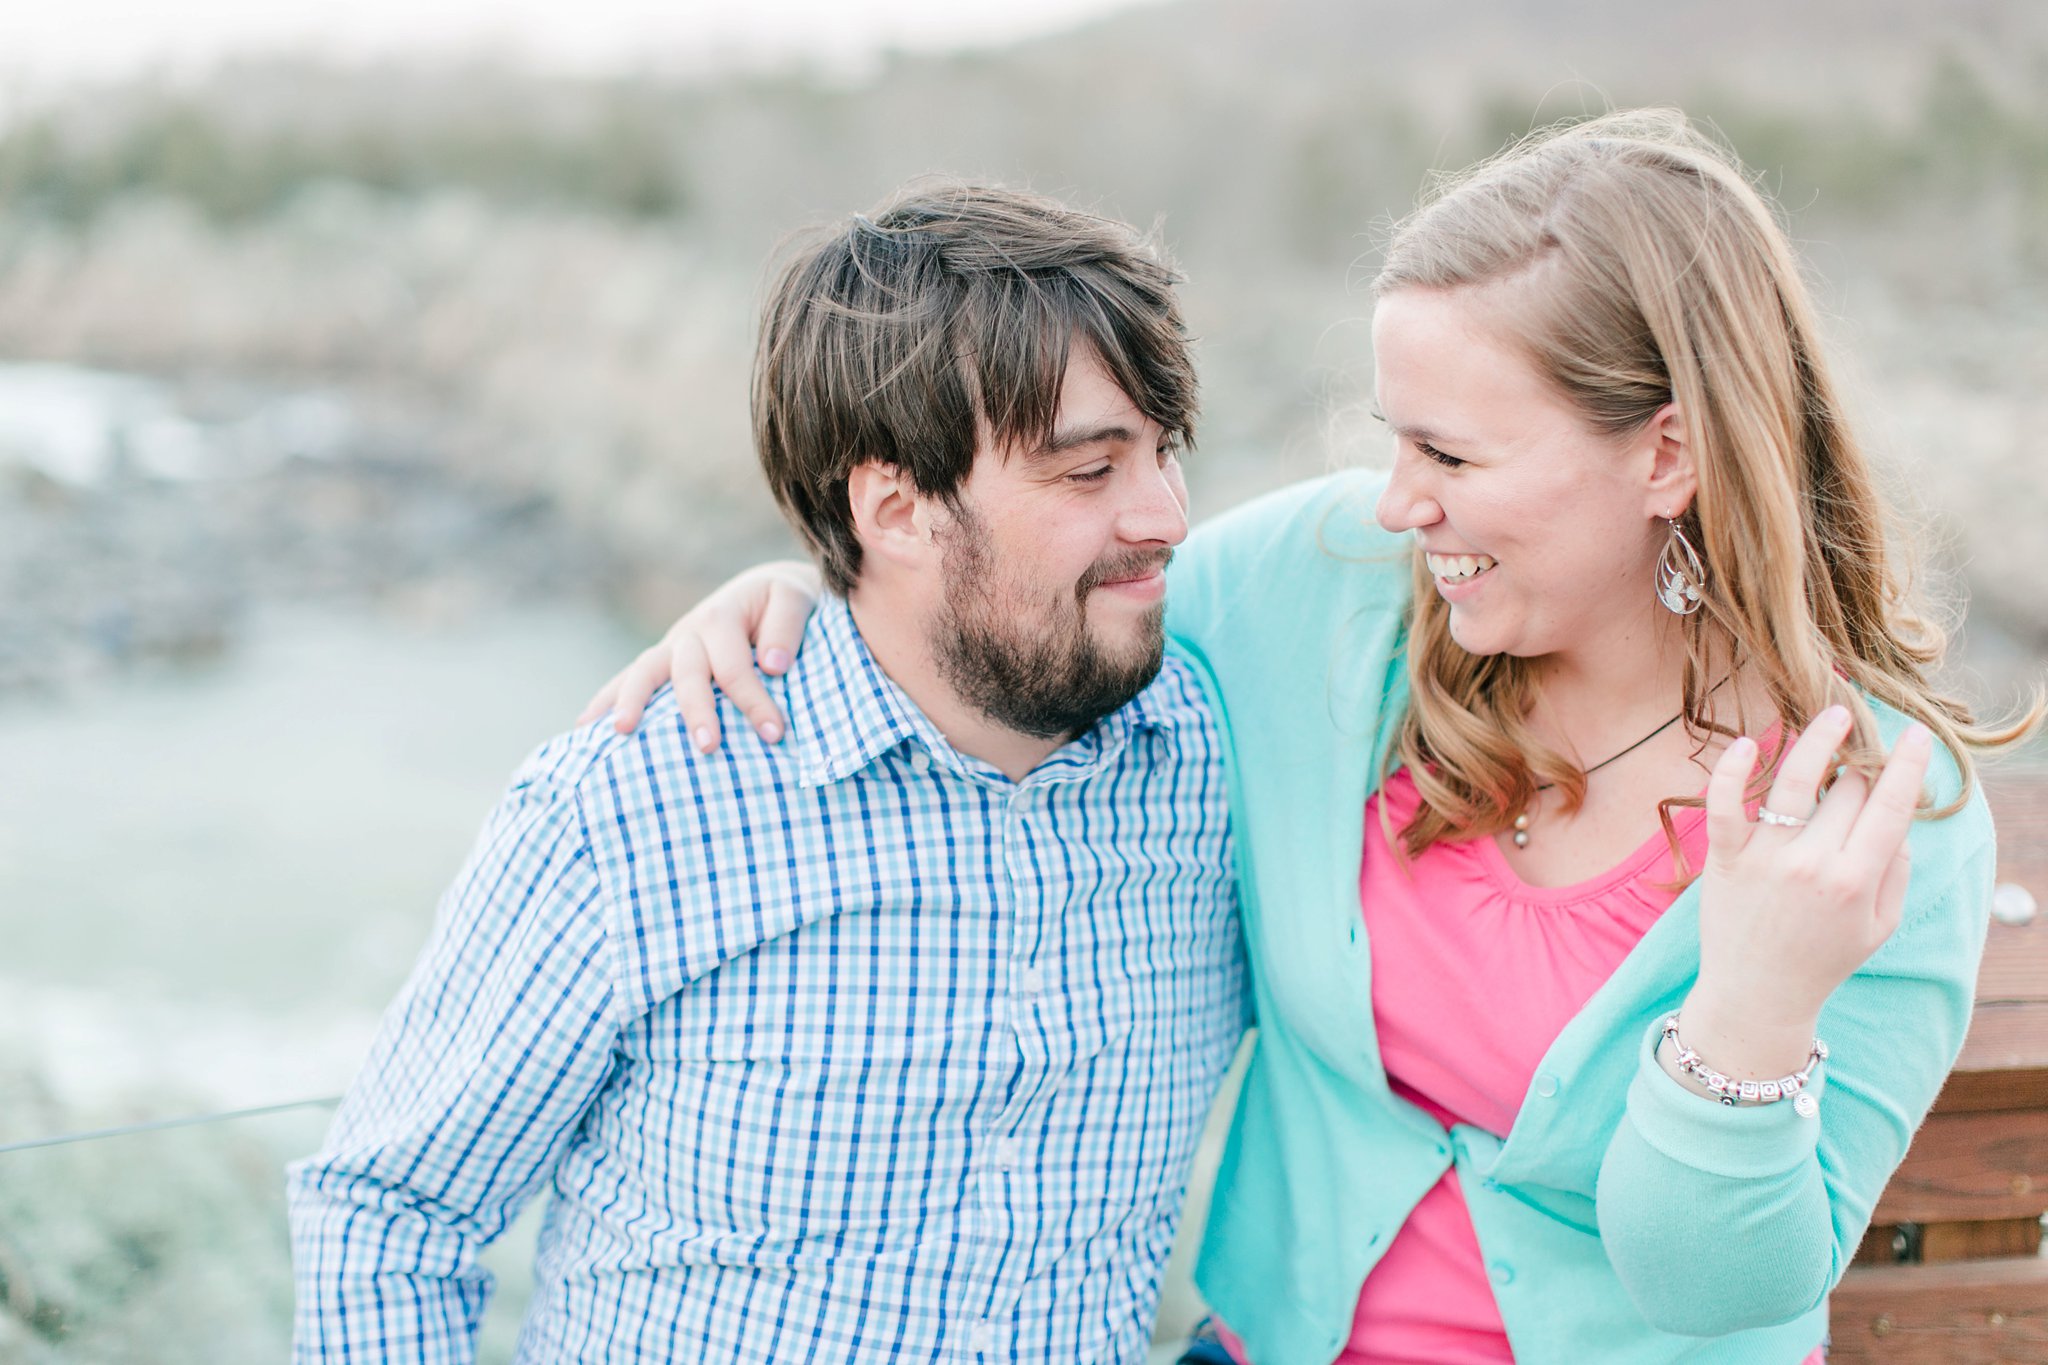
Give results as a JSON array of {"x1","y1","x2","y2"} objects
[{"x1": 1829, "y1": 778, "x2": 2048, "y2": 1365}]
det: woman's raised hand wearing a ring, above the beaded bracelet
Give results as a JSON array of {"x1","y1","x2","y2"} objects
[{"x1": 1681, "y1": 706, "x2": 1933, "y2": 1081}]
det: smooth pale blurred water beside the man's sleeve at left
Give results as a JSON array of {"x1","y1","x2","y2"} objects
[{"x1": 0, "y1": 604, "x2": 631, "y2": 1140}]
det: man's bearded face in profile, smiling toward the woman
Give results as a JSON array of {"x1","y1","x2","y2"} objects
[{"x1": 932, "y1": 346, "x2": 1188, "y2": 739}]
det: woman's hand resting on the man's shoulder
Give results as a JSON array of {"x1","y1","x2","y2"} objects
[{"x1": 575, "y1": 559, "x2": 823, "y2": 753}]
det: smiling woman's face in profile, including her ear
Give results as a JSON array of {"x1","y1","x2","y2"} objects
[{"x1": 1372, "y1": 287, "x2": 1692, "y2": 667}]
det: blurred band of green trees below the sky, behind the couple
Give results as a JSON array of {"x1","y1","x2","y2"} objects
[{"x1": 0, "y1": 51, "x2": 2048, "y2": 300}]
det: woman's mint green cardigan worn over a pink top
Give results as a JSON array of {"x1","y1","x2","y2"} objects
[{"x1": 1167, "y1": 473, "x2": 1993, "y2": 1365}]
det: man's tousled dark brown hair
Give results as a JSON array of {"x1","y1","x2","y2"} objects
[{"x1": 754, "y1": 180, "x2": 1196, "y2": 593}]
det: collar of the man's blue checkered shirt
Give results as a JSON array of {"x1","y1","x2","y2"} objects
[{"x1": 784, "y1": 593, "x2": 1184, "y2": 786}]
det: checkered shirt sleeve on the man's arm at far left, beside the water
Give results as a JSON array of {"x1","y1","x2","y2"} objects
[{"x1": 289, "y1": 772, "x2": 616, "y2": 1365}]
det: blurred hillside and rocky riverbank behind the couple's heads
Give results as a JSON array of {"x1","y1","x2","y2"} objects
[{"x1": 0, "y1": 0, "x2": 2048, "y2": 688}]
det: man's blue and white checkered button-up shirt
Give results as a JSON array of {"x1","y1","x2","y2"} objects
[{"x1": 291, "y1": 600, "x2": 1245, "y2": 1365}]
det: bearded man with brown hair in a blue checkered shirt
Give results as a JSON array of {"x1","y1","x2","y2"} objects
[{"x1": 291, "y1": 186, "x2": 1245, "y2": 1363}]
